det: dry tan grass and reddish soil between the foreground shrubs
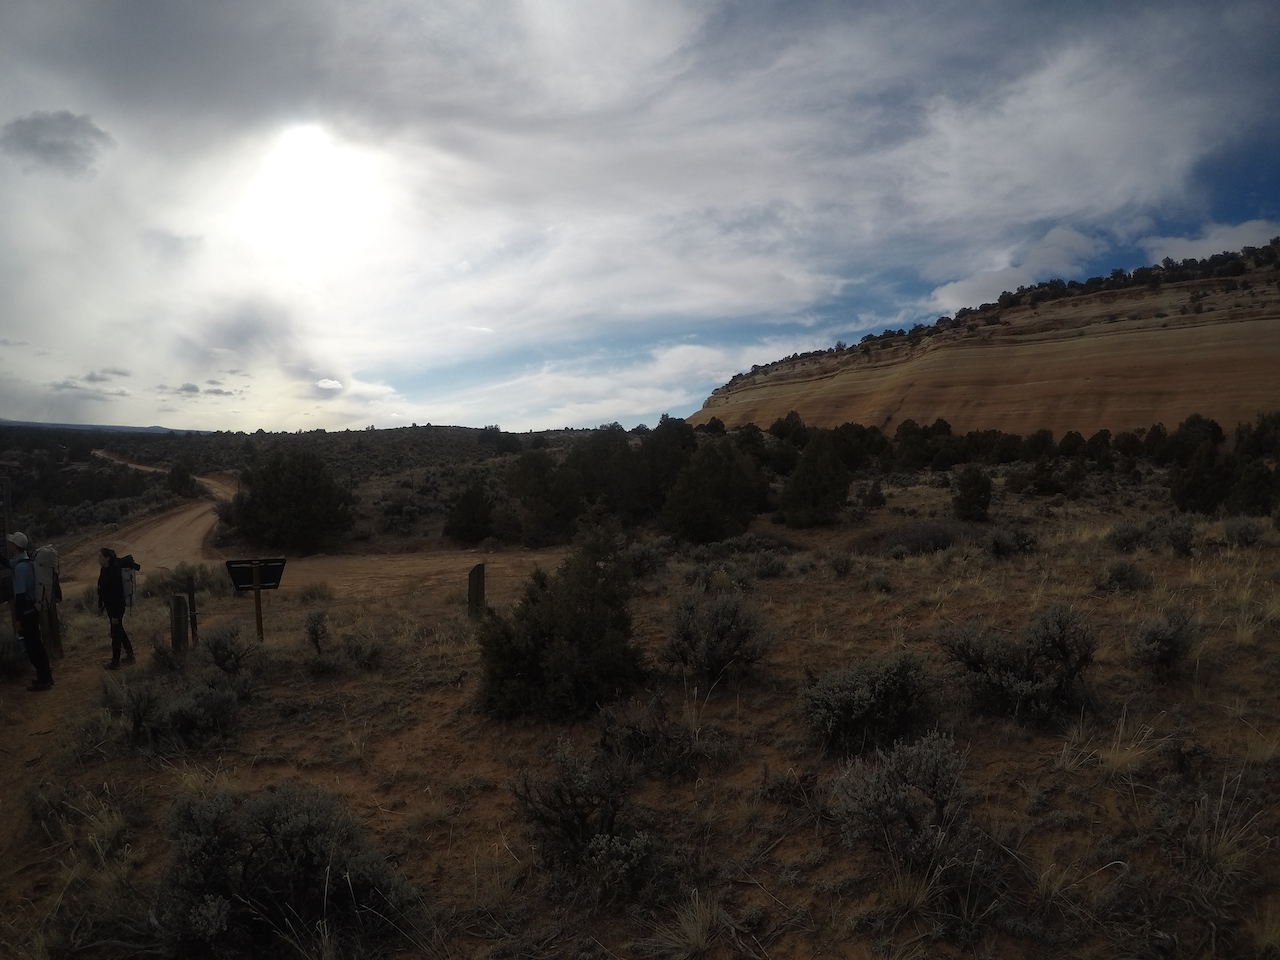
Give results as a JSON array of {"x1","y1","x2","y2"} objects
[{"x1": 0, "y1": 463, "x2": 1280, "y2": 960}]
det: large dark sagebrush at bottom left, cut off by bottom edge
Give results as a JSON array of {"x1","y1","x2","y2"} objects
[{"x1": 156, "y1": 783, "x2": 413, "y2": 957}]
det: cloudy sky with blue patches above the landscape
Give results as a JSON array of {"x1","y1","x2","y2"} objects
[{"x1": 0, "y1": 0, "x2": 1280, "y2": 430}]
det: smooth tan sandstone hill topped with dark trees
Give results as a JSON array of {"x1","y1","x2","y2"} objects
[{"x1": 690, "y1": 238, "x2": 1280, "y2": 436}]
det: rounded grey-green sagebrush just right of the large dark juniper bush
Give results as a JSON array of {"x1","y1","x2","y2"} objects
[{"x1": 666, "y1": 590, "x2": 769, "y2": 682}]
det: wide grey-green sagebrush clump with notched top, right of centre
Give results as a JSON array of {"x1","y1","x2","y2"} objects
[{"x1": 938, "y1": 604, "x2": 1098, "y2": 723}]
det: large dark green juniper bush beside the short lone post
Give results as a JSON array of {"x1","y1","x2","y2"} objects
[{"x1": 477, "y1": 530, "x2": 641, "y2": 718}]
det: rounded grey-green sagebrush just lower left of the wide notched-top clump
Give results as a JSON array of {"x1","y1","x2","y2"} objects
[{"x1": 801, "y1": 653, "x2": 929, "y2": 753}]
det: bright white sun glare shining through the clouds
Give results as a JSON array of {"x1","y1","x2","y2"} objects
[{"x1": 238, "y1": 125, "x2": 383, "y2": 269}]
